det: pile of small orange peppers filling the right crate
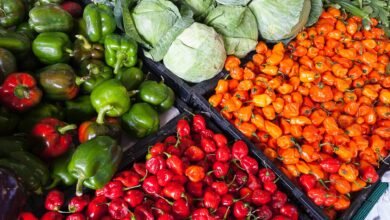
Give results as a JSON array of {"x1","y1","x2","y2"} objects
[{"x1": 209, "y1": 8, "x2": 390, "y2": 218}]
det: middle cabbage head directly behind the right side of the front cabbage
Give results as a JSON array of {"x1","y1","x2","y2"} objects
[{"x1": 205, "y1": 5, "x2": 259, "y2": 57}]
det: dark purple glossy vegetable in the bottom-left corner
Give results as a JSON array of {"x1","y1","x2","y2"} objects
[{"x1": 0, "y1": 168, "x2": 27, "y2": 219}]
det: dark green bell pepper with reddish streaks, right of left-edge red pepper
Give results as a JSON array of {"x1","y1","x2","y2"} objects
[{"x1": 38, "y1": 63, "x2": 79, "y2": 101}]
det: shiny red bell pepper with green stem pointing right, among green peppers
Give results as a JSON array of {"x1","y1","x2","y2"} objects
[{"x1": 32, "y1": 118, "x2": 77, "y2": 158}]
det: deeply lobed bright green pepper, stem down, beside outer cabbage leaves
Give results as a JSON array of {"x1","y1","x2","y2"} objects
[{"x1": 104, "y1": 34, "x2": 138, "y2": 74}]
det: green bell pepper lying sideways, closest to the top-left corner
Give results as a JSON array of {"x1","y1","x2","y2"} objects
[{"x1": 28, "y1": 4, "x2": 73, "y2": 33}]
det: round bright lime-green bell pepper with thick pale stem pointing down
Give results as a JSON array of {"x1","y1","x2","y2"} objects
[{"x1": 91, "y1": 79, "x2": 131, "y2": 124}]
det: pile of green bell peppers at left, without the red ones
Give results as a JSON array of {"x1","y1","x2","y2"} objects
[{"x1": 0, "y1": 0, "x2": 175, "y2": 199}]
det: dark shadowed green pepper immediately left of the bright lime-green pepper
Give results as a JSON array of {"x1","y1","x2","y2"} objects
[{"x1": 65, "y1": 95, "x2": 96, "y2": 123}]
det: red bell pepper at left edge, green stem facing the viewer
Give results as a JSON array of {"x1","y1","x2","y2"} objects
[{"x1": 0, "y1": 73, "x2": 42, "y2": 111}]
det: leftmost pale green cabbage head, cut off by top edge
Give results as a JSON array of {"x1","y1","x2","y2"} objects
[{"x1": 131, "y1": 0, "x2": 180, "y2": 47}]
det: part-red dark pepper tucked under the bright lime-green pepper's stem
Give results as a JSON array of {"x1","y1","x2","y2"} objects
[{"x1": 78, "y1": 118, "x2": 122, "y2": 143}]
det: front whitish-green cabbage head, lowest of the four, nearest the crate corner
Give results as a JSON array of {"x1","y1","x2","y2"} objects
[{"x1": 164, "y1": 22, "x2": 226, "y2": 83}]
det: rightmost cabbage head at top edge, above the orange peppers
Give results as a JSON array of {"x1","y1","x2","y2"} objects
[{"x1": 249, "y1": 0, "x2": 311, "y2": 42}]
